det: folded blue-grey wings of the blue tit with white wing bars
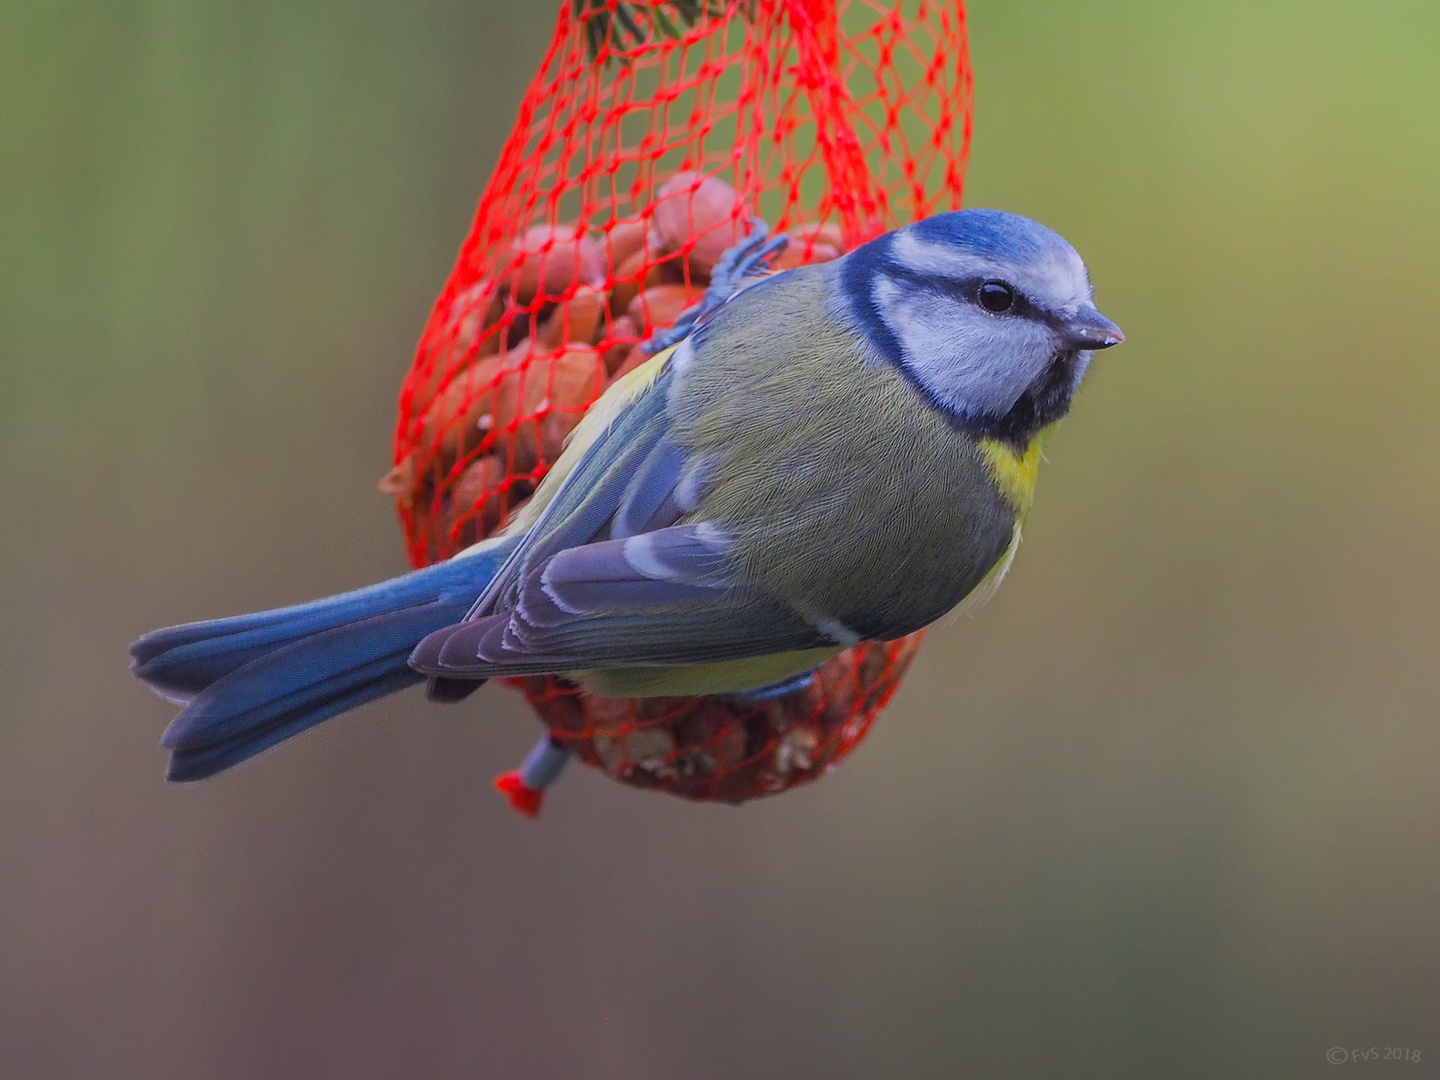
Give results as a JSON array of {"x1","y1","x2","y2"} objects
[{"x1": 410, "y1": 344, "x2": 851, "y2": 678}]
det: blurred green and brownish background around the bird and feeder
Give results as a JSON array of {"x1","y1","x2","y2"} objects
[{"x1": 0, "y1": 0, "x2": 1440, "y2": 1080}]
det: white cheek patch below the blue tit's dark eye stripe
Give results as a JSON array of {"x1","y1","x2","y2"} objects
[{"x1": 871, "y1": 275, "x2": 1054, "y2": 416}]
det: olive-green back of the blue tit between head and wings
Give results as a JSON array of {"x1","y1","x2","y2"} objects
[{"x1": 671, "y1": 264, "x2": 1015, "y2": 638}]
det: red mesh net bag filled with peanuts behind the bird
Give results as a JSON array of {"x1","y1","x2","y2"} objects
[{"x1": 382, "y1": 0, "x2": 971, "y2": 809}]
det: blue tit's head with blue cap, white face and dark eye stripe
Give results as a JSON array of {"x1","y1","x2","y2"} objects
[{"x1": 837, "y1": 210, "x2": 1125, "y2": 445}]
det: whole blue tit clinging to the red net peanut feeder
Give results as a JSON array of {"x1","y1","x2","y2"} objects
[{"x1": 131, "y1": 210, "x2": 1123, "y2": 780}]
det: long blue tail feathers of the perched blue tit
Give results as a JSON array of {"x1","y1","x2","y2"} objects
[{"x1": 130, "y1": 537, "x2": 518, "y2": 780}]
